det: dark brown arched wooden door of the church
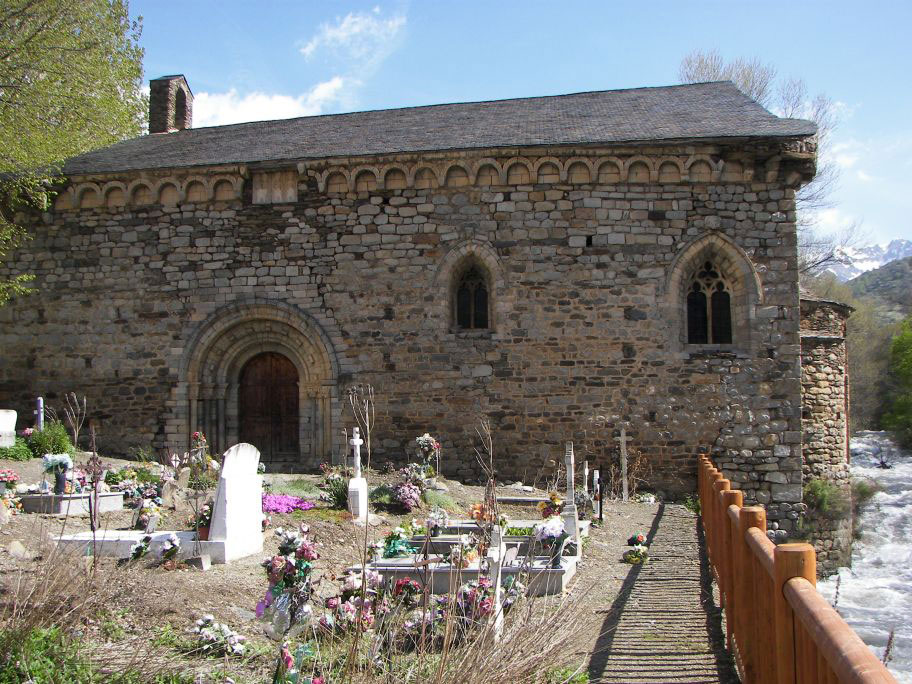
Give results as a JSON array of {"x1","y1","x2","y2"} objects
[{"x1": 238, "y1": 352, "x2": 300, "y2": 463}]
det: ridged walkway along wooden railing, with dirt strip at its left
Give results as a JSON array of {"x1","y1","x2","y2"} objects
[{"x1": 577, "y1": 504, "x2": 738, "y2": 684}]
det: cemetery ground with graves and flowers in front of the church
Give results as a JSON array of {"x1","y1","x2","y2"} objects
[{"x1": 0, "y1": 398, "x2": 688, "y2": 681}]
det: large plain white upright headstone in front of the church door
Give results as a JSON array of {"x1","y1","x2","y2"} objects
[{"x1": 209, "y1": 444, "x2": 263, "y2": 562}]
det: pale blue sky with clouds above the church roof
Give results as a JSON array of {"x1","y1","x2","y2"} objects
[{"x1": 131, "y1": 0, "x2": 912, "y2": 242}]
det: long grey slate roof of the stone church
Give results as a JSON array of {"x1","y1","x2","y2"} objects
[{"x1": 64, "y1": 81, "x2": 816, "y2": 174}]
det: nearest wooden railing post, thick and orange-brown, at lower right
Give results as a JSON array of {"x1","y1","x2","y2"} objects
[{"x1": 773, "y1": 544, "x2": 817, "y2": 684}]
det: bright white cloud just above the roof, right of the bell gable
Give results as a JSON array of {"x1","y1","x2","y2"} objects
[{"x1": 193, "y1": 76, "x2": 350, "y2": 128}]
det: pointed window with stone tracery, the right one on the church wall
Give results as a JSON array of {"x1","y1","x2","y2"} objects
[{"x1": 687, "y1": 261, "x2": 732, "y2": 344}]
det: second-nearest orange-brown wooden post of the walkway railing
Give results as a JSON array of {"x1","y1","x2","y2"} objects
[{"x1": 735, "y1": 506, "x2": 773, "y2": 684}]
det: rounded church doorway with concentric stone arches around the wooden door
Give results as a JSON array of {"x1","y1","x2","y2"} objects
[{"x1": 172, "y1": 300, "x2": 341, "y2": 472}]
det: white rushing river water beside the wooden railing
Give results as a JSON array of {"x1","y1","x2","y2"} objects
[{"x1": 818, "y1": 432, "x2": 912, "y2": 684}]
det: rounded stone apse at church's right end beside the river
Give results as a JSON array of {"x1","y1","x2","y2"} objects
[{"x1": 801, "y1": 297, "x2": 852, "y2": 574}]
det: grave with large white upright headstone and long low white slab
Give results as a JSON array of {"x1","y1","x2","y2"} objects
[{"x1": 57, "y1": 444, "x2": 263, "y2": 564}]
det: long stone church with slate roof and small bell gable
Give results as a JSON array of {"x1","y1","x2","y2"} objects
[{"x1": 0, "y1": 76, "x2": 856, "y2": 544}]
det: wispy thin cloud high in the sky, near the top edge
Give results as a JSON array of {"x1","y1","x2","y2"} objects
[{"x1": 301, "y1": 7, "x2": 406, "y2": 69}]
